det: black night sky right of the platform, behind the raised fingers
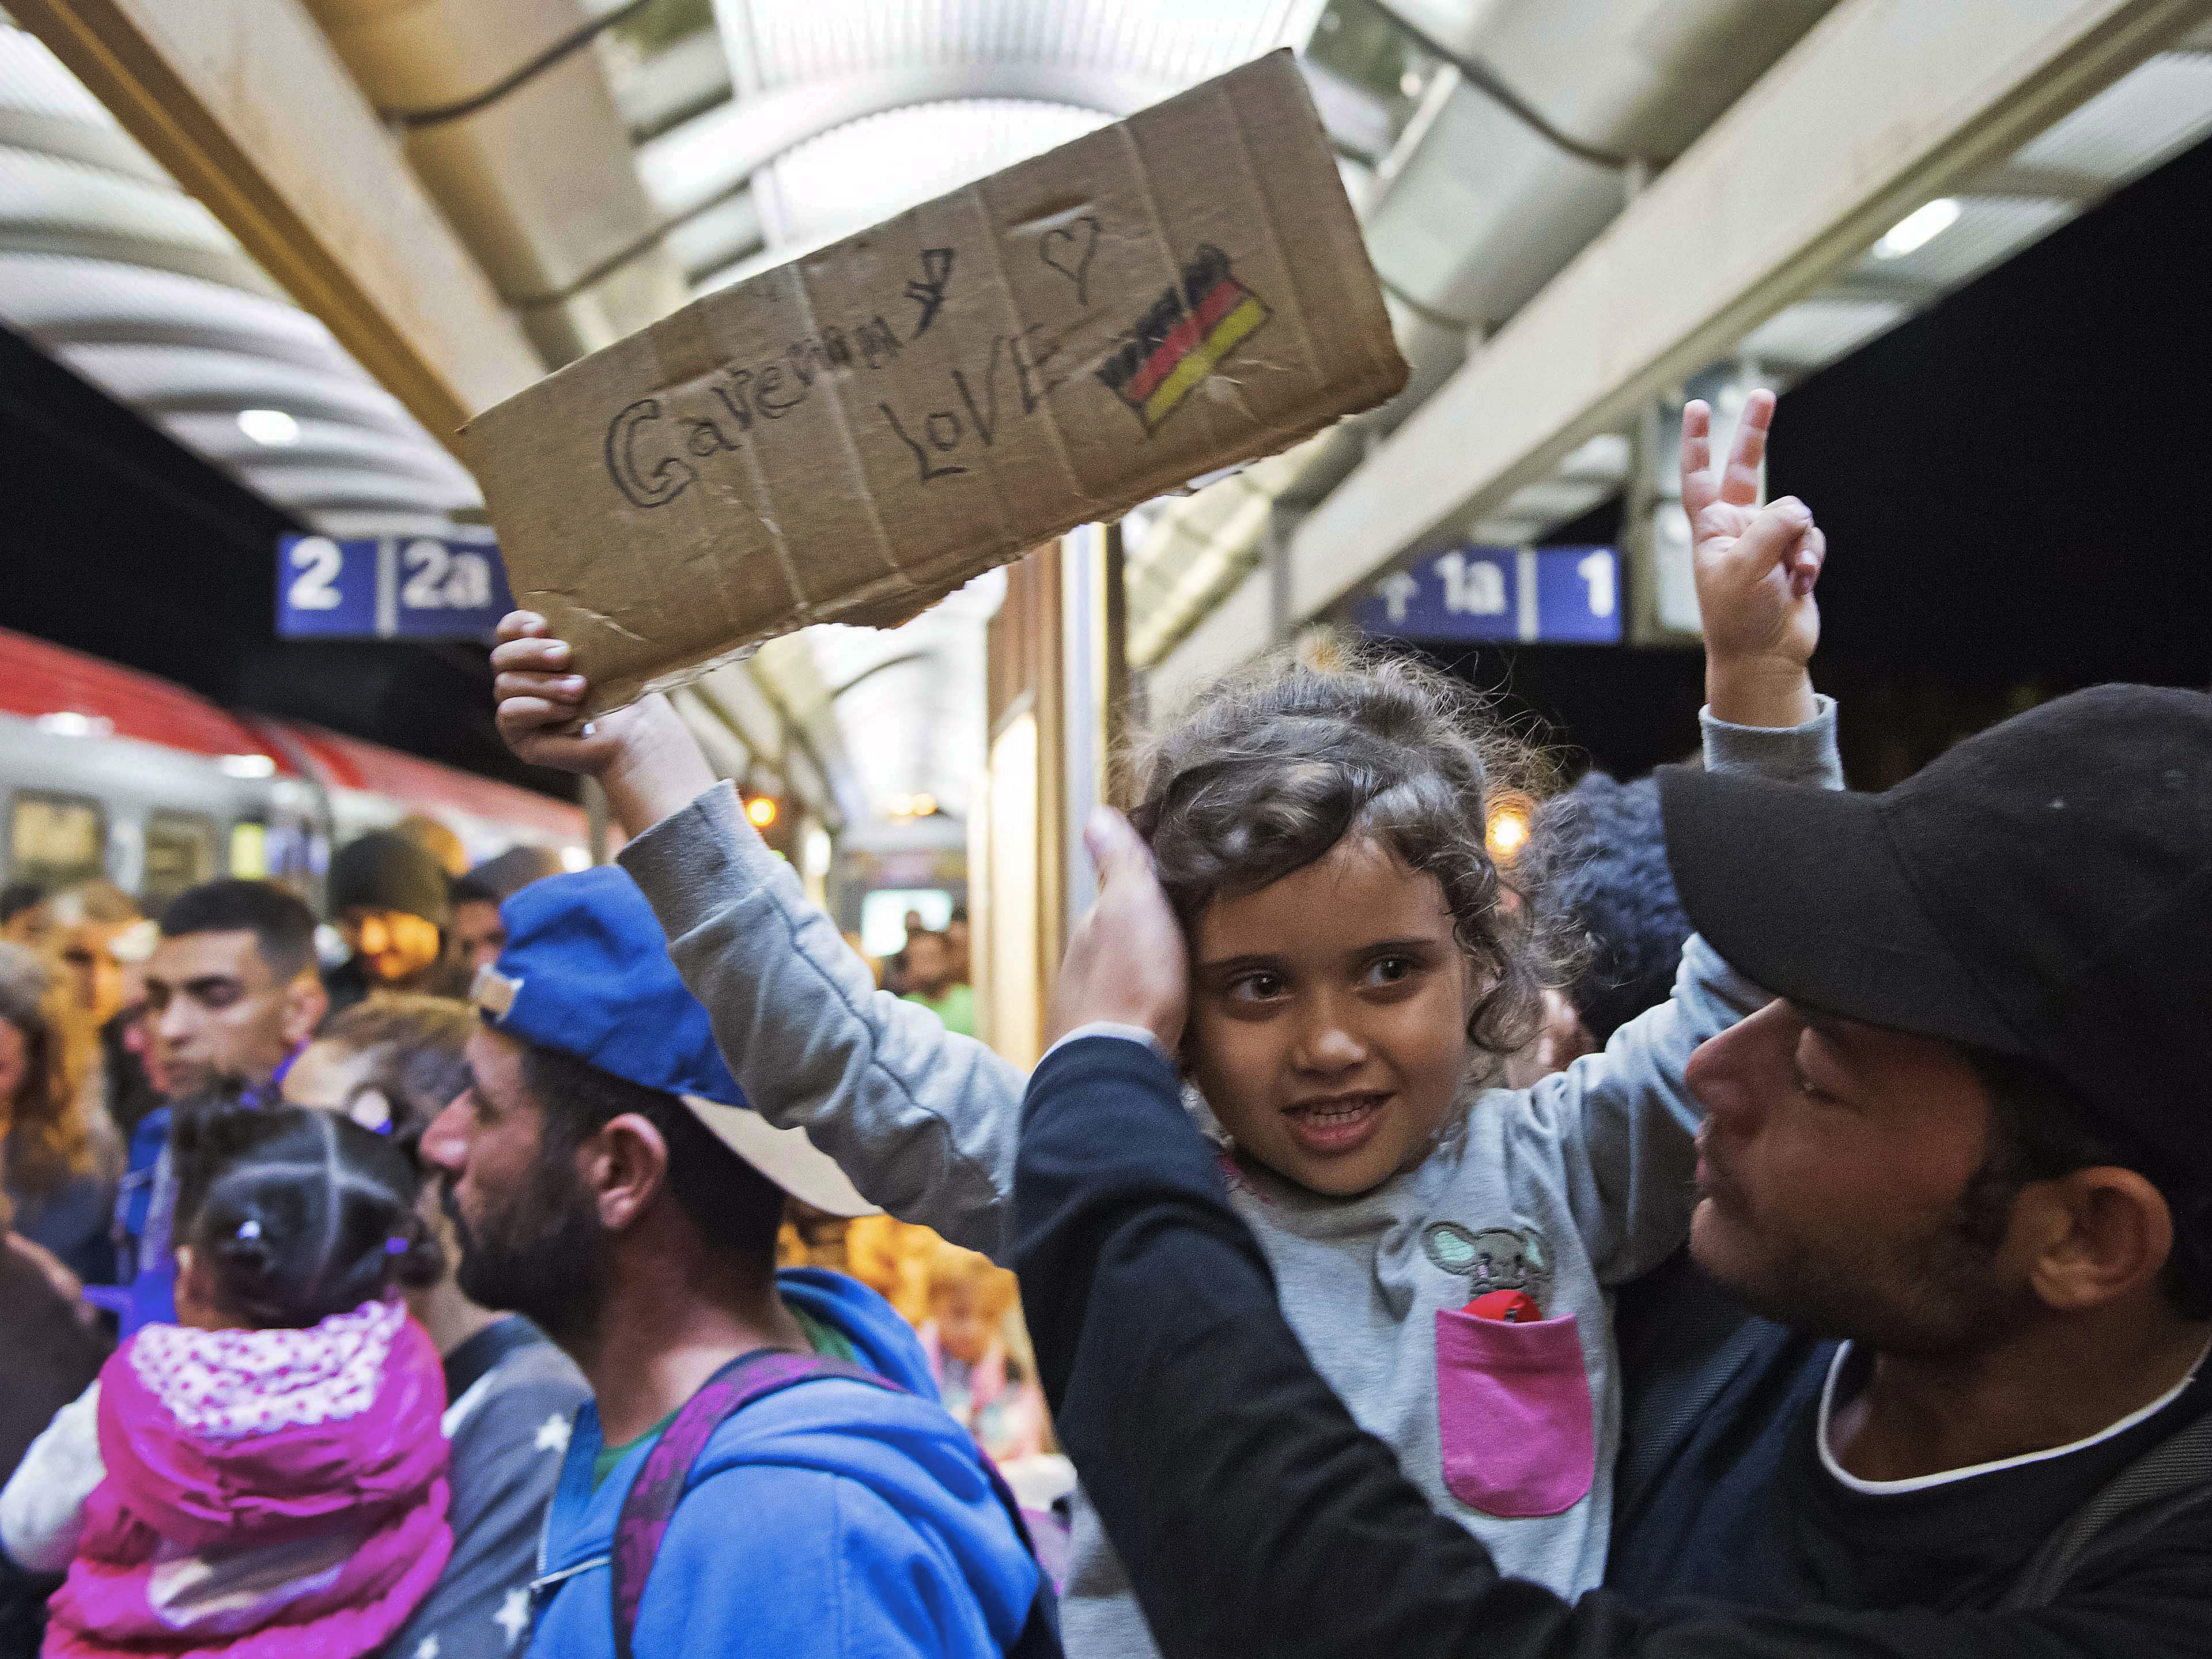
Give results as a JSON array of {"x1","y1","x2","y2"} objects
[{"x1": 1438, "y1": 126, "x2": 2212, "y2": 788}]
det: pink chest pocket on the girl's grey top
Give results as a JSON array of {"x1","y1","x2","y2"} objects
[{"x1": 1436, "y1": 1309, "x2": 1597, "y2": 1520}]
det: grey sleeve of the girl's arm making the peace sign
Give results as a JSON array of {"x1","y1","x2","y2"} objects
[{"x1": 1518, "y1": 697, "x2": 1843, "y2": 1285}]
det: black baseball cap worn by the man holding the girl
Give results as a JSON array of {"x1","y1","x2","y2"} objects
[{"x1": 1659, "y1": 686, "x2": 2212, "y2": 1192}]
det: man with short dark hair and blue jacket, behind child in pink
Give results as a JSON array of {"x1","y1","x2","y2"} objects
[{"x1": 115, "y1": 880, "x2": 330, "y2": 1336}]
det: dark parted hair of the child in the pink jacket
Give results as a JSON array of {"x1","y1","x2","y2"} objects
[{"x1": 175, "y1": 1104, "x2": 443, "y2": 1329}]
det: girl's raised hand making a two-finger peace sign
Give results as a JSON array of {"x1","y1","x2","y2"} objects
[{"x1": 1681, "y1": 391, "x2": 1827, "y2": 725}]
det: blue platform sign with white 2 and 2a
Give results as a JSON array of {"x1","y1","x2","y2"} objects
[{"x1": 277, "y1": 546, "x2": 513, "y2": 639}]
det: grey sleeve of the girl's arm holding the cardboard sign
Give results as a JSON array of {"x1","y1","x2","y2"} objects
[{"x1": 622, "y1": 783, "x2": 1029, "y2": 1256}]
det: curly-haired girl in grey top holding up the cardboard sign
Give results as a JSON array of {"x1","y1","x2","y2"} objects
[{"x1": 496, "y1": 394, "x2": 1840, "y2": 1654}]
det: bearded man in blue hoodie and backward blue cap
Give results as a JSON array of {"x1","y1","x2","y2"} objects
[{"x1": 422, "y1": 867, "x2": 1057, "y2": 1659}]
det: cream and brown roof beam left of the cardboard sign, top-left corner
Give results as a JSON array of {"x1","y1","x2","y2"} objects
[{"x1": 9, "y1": 0, "x2": 544, "y2": 447}]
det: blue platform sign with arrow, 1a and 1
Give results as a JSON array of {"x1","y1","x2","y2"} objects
[{"x1": 1352, "y1": 546, "x2": 1621, "y2": 646}]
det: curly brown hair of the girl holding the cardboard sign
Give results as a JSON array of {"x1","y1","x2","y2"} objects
[{"x1": 1130, "y1": 641, "x2": 1548, "y2": 1055}]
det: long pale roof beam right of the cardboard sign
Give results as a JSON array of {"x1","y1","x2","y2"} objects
[{"x1": 1166, "y1": 0, "x2": 2212, "y2": 681}]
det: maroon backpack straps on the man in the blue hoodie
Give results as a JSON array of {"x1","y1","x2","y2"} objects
[{"x1": 608, "y1": 1347, "x2": 1062, "y2": 1659}]
